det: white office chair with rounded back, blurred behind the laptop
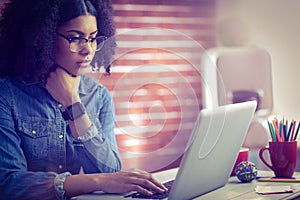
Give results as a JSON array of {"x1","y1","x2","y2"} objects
[{"x1": 201, "y1": 47, "x2": 273, "y2": 149}]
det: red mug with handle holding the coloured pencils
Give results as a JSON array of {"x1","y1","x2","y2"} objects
[{"x1": 259, "y1": 141, "x2": 297, "y2": 178}]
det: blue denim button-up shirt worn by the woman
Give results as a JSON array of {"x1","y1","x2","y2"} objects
[{"x1": 0, "y1": 76, "x2": 121, "y2": 200}]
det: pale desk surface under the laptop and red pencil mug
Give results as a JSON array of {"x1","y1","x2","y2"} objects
[{"x1": 72, "y1": 169, "x2": 300, "y2": 200}]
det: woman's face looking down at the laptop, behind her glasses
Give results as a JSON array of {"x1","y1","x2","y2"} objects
[{"x1": 54, "y1": 15, "x2": 97, "y2": 75}]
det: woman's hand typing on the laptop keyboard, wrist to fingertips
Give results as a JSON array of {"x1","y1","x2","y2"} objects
[{"x1": 101, "y1": 169, "x2": 167, "y2": 195}]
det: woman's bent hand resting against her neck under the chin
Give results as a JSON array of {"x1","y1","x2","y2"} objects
[{"x1": 46, "y1": 67, "x2": 80, "y2": 107}]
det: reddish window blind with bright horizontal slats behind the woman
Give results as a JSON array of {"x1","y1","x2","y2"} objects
[{"x1": 99, "y1": 0, "x2": 216, "y2": 172}]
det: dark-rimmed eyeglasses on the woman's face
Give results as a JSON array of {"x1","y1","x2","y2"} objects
[{"x1": 56, "y1": 32, "x2": 107, "y2": 53}]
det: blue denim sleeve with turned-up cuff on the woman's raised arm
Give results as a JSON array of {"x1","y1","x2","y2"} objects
[{"x1": 73, "y1": 86, "x2": 121, "y2": 173}]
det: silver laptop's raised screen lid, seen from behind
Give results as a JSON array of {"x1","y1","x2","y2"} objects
[{"x1": 76, "y1": 101, "x2": 257, "y2": 200}]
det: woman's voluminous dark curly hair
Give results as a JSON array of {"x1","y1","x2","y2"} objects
[{"x1": 0, "y1": 0, "x2": 116, "y2": 81}]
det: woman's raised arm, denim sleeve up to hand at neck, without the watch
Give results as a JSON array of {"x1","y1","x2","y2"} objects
[{"x1": 46, "y1": 68, "x2": 121, "y2": 173}]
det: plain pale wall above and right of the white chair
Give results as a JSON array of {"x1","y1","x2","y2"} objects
[{"x1": 217, "y1": 0, "x2": 300, "y2": 120}]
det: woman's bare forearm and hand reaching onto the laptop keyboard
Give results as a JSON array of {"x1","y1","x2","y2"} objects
[{"x1": 64, "y1": 169, "x2": 168, "y2": 197}]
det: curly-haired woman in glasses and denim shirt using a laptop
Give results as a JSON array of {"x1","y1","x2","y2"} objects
[{"x1": 0, "y1": 0, "x2": 166, "y2": 199}]
